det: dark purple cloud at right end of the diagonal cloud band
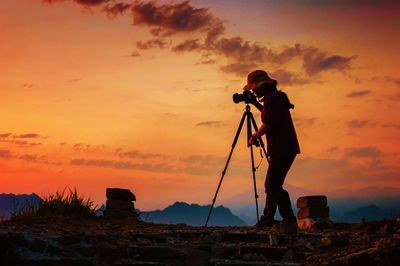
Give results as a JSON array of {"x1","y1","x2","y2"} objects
[{"x1": 303, "y1": 48, "x2": 355, "y2": 76}]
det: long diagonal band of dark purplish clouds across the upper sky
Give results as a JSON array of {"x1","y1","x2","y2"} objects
[{"x1": 43, "y1": 0, "x2": 355, "y2": 79}]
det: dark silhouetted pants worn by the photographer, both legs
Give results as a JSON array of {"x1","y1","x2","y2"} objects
[{"x1": 264, "y1": 155, "x2": 296, "y2": 222}]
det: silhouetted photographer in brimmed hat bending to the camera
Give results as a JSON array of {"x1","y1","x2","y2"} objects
[{"x1": 243, "y1": 70, "x2": 300, "y2": 231}]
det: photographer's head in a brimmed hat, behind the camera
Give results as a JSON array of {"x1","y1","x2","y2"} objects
[{"x1": 243, "y1": 70, "x2": 277, "y2": 97}]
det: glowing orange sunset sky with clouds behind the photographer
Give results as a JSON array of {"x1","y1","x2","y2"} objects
[{"x1": 0, "y1": 0, "x2": 400, "y2": 209}]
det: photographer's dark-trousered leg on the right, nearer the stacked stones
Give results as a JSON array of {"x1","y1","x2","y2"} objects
[{"x1": 267, "y1": 156, "x2": 296, "y2": 222}]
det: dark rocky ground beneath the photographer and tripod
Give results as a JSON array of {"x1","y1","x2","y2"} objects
[{"x1": 0, "y1": 218, "x2": 400, "y2": 266}]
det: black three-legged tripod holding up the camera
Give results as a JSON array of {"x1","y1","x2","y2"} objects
[{"x1": 204, "y1": 103, "x2": 269, "y2": 227}]
